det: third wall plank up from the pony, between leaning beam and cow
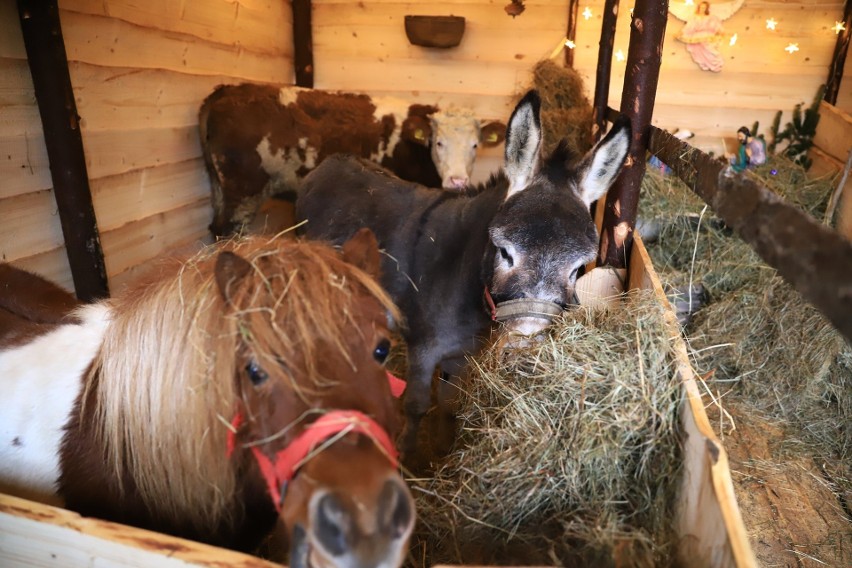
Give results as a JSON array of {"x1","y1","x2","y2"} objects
[{"x1": 83, "y1": 126, "x2": 201, "y2": 180}]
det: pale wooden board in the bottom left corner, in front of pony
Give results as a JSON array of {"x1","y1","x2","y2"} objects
[{"x1": 0, "y1": 495, "x2": 279, "y2": 568}]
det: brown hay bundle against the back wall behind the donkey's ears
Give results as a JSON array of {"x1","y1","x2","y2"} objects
[{"x1": 532, "y1": 59, "x2": 592, "y2": 156}]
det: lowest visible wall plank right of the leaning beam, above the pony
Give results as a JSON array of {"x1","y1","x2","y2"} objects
[{"x1": 101, "y1": 197, "x2": 213, "y2": 279}]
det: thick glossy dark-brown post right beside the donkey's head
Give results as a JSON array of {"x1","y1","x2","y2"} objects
[{"x1": 598, "y1": 0, "x2": 669, "y2": 268}]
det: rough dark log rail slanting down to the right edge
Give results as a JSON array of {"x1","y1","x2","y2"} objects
[{"x1": 649, "y1": 126, "x2": 852, "y2": 341}]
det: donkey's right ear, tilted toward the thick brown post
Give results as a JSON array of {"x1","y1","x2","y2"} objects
[{"x1": 577, "y1": 115, "x2": 631, "y2": 207}]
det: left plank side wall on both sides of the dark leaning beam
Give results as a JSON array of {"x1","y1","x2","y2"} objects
[{"x1": 0, "y1": 0, "x2": 293, "y2": 292}]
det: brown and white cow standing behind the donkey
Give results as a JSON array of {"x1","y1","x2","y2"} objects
[{"x1": 199, "y1": 83, "x2": 505, "y2": 236}]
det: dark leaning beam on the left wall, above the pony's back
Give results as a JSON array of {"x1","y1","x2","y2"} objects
[{"x1": 18, "y1": 0, "x2": 109, "y2": 301}]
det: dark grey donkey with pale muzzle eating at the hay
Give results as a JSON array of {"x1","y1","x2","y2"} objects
[{"x1": 296, "y1": 91, "x2": 631, "y2": 457}]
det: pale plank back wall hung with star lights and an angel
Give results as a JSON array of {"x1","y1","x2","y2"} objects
[{"x1": 313, "y1": 0, "x2": 852, "y2": 166}]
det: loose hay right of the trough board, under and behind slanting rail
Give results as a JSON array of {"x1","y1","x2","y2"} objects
[{"x1": 640, "y1": 157, "x2": 852, "y2": 495}]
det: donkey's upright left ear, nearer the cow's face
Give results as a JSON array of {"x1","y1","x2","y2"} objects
[{"x1": 503, "y1": 91, "x2": 541, "y2": 199}]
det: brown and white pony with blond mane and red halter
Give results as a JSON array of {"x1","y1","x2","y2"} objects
[{"x1": 0, "y1": 232, "x2": 414, "y2": 567}]
